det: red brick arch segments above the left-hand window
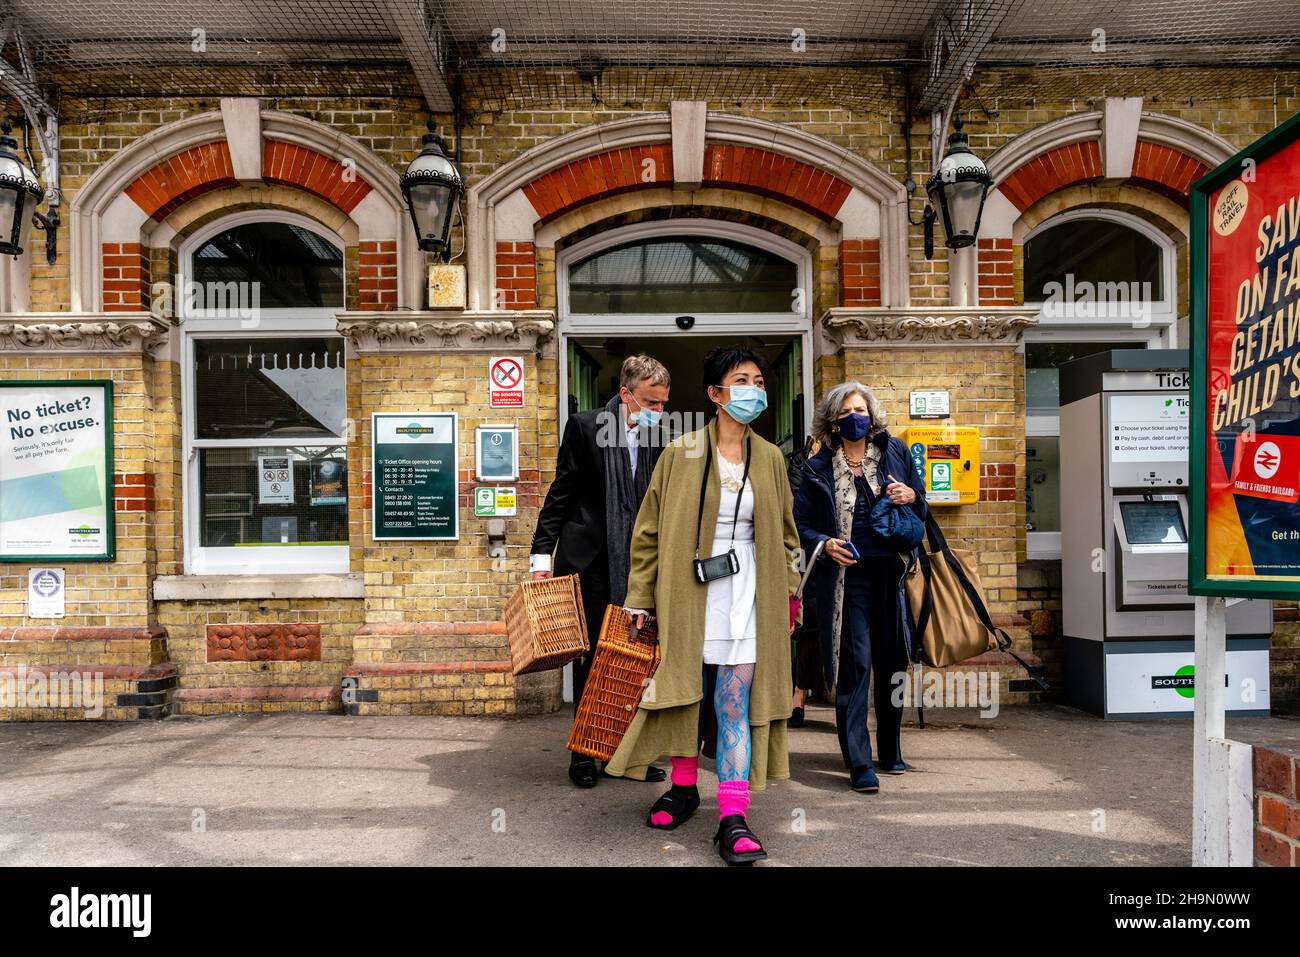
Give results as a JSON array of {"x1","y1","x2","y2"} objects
[{"x1": 126, "y1": 139, "x2": 373, "y2": 222}]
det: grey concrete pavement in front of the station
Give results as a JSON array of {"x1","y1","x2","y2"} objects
[{"x1": 0, "y1": 706, "x2": 1300, "y2": 866}]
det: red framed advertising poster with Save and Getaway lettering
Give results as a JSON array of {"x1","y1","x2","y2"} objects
[{"x1": 1188, "y1": 116, "x2": 1300, "y2": 598}]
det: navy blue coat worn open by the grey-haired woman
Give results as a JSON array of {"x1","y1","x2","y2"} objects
[{"x1": 794, "y1": 429, "x2": 928, "y2": 687}]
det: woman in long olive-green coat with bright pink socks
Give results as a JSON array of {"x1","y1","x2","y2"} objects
[{"x1": 606, "y1": 347, "x2": 801, "y2": 863}]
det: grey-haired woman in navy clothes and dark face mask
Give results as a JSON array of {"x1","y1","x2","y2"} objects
[{"x1": 794, "y1": 381, "x2": 926, "y2": 793}]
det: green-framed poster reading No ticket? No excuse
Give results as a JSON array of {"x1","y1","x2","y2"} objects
[{"x1": 0, "y1": 380, "x2": 115, "y2": 563}]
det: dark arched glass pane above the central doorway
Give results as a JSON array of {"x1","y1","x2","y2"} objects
[{"x1": 568, "y1": 235, "x2": 800, "y2": 315}]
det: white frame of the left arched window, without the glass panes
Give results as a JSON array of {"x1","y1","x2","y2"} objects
[{"x1": 176, "y1": 209, "x2": 351, "y2": 575}]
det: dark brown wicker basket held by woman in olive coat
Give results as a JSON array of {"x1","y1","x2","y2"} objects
[{"x1": 568, "y1": 605, "x2": 659, "y2": 761}]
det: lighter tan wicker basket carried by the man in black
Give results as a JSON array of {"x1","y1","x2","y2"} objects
[{"x1": 506, "y1": 575, "x2": 588, "y2": 675}]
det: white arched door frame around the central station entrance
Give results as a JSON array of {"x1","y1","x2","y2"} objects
[{"x1": 555, "y1": 218, "x2": 815, "y2": 434}]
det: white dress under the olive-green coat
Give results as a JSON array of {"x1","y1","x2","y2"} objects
[{"x1": 705, "y1": 455, "x2": 758, "y2": 664}]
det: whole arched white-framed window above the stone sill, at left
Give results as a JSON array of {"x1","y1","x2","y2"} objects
[{"x1": 177, "y1": 211, "x2": 348, "y2": 575}]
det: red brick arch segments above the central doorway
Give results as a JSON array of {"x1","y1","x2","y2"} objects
[{"x1": 523, "y1": 143, "x2": 853, "y2": 222}]
